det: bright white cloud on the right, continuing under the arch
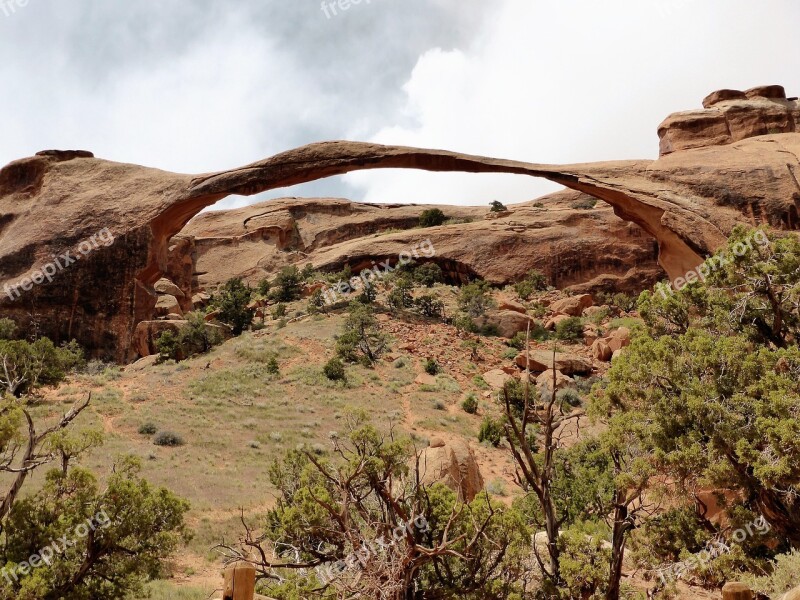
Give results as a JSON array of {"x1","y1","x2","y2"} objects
[{"x1": 346, "y1": 0, "x2": 800, "y2": 204}]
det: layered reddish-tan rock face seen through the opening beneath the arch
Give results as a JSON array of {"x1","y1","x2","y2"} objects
[{"x1": 181, "y1": 191, "x2": 663, "y2": 290}]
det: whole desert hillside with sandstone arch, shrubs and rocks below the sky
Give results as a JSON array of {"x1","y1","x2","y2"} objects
[{"x1": 0, "y1": 86, "x2": 800, "y2": 600}]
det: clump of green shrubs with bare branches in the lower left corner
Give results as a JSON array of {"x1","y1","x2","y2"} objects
[{"x1": 0, "y1": 332, "x2": 188, "y2": 600}]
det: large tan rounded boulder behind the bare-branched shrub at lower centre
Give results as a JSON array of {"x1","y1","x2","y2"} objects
[{"x1": 420, "y1": 440, "x2": 483, "y2": 502}]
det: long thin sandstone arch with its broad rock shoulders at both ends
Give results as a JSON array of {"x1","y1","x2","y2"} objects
[{"x1": 0, "y1": 92, "x2": 800, "y2": 361}]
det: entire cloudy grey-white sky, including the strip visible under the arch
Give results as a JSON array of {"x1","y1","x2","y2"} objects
[{"x1": 0, "y1": 0, "x2": 800, "y2": 208}]
